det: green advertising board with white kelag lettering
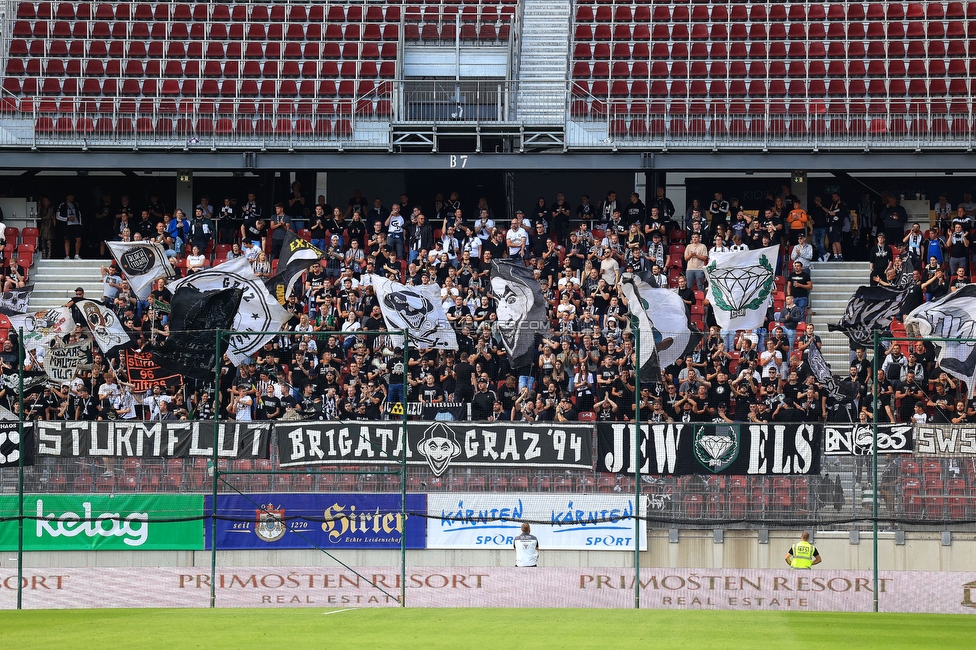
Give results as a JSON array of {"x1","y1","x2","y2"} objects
[{"x1": 0, "y1": 494, "x2": 203, "y2": 551}]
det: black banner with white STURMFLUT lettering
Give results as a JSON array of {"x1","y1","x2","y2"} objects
[{"x1": 36, "y1": 420, "x2": 271, "y2": 458}]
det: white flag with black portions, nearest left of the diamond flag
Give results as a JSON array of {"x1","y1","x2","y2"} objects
[{"x1": 620, "y1": 273, "x2": 701, "y2": 381}]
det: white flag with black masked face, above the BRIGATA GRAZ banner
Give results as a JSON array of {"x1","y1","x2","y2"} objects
[{"x1": 363, "y1": 275, "x2": 457, "y2": 350}]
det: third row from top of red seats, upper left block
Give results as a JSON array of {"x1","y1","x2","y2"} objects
[{"x1": 10, "y1": 39, "x2": 397, "y2": 61}]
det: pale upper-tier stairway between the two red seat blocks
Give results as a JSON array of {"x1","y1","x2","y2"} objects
[{"x1": 518, "y1": 0, "x2": 571, "y2": 125}]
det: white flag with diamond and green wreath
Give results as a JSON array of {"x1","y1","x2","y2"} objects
[{"x1": 705, "y1": 246, "x2": 779, "y2": 330}]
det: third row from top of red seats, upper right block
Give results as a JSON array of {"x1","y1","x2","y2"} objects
[{"x1": 573, "y1": 39, "x2": 976, "y2": 61}]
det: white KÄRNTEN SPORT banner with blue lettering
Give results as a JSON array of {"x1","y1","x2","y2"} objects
[{"x1": 427, "y1": 492, "x2": 647, "y2": 548}]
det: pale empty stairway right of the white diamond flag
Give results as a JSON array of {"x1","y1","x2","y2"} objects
[{"x1": 807, "y1": 262, "x2": 871, "y2": 370}]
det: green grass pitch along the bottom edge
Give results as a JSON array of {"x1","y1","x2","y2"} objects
[{"x1": 0, "y1": 609, "x2": 976, "y2": 650}]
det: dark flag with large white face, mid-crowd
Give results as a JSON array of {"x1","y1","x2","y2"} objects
[{"x1": 491, "y1": 260, "x2": 549, "y2": 368}]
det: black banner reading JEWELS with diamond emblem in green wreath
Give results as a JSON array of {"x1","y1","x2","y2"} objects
[{"x1": 597, "y1": 422, "x2": 822, "y2": 475}]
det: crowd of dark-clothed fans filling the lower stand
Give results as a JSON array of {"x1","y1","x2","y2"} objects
[{"x1": 11, "y1": 183, "x2": 976, "y2": 422}]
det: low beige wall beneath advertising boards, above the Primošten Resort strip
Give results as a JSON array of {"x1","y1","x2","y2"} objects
[{"x1": 7, "y1": 529, "x2": 976, "y2": 572}]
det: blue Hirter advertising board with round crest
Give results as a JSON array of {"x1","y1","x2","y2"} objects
[{"x1": 204, "y1": 493, "x2": 427, "y2": 550}]
